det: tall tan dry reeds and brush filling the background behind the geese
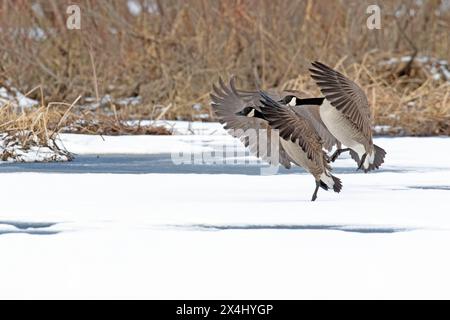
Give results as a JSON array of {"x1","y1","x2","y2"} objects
[{"x1": 0, "y1": 0, "x2": 450, "y2": 135}]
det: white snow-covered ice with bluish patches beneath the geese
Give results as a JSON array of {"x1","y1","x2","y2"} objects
[{"x1": 0, "y1": 123, "x2": 450, "y2": 299}]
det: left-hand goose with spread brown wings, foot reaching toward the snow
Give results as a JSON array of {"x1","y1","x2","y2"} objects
[{"x1": 211, "y1": 78, "x2": 342, "y2": 201}]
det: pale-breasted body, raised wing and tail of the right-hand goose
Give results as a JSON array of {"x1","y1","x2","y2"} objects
[{"x1": 309, "y1": 61, "x2": 386, "y2": 172}]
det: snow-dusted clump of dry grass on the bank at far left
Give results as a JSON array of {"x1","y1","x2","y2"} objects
[{"x1": 0, "y1": 91, "x2": 172, "y2": 161}]
